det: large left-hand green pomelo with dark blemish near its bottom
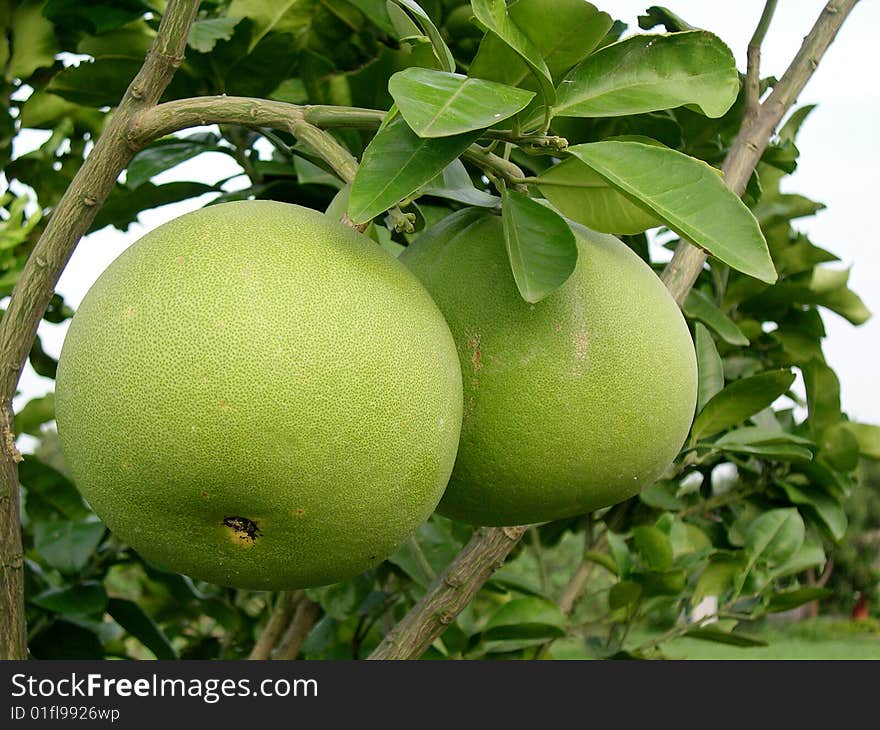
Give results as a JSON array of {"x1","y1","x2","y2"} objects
[{"x1": 56, "y1": 201, "x2": 461, "y2": 589}]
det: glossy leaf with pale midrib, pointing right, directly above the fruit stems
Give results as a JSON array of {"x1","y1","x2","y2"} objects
[{"x1": 388, "y1": 68, "x2": 535, "y2": 137}]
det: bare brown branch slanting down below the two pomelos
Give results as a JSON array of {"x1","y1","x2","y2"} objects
[{"x1": 368, "y1": 527, "x2": 526, "y2": 659}]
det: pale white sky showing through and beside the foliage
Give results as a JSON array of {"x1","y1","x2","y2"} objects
[{"x1": 6, "y1": 0, "x2": 880, "y2": 424}]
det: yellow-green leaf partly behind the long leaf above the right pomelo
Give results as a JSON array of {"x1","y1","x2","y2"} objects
[{"x1": 538, "y1": 157, "x2": 660, "y2": 234}]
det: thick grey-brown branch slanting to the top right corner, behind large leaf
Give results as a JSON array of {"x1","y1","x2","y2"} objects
[{"x1": 662, "y1": 0, "x2": 858, "y2": 304}]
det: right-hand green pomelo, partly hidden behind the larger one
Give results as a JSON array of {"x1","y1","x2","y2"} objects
[{"x1": 401, "y1": 211, "x2": 697, "y2": 525}]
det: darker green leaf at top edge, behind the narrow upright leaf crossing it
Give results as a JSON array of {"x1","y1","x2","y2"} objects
[{"x1": 468, "y1": 0, "x2": 612, "y2": 86}]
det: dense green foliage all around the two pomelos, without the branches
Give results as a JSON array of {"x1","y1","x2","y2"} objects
[{"x1": 0, "y1": 0, "x2": 880, "y2": 658}]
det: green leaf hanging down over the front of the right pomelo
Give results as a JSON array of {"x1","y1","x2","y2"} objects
[{"x1": 501, "y1": 189, "x2": 578, "y2": 304}]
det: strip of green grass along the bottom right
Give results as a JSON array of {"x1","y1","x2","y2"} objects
[{"x1": 552, "y1": 619, "x2": 880, "y2": 660}]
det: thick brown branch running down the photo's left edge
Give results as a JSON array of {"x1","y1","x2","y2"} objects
[{"x1": 0, "y1": 0, "x2": 199, "y2": 659}]
